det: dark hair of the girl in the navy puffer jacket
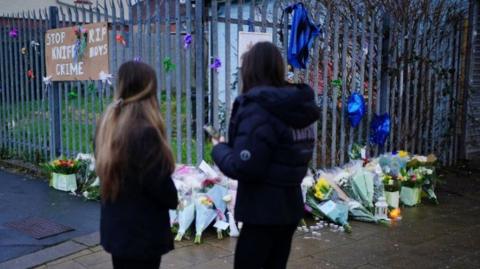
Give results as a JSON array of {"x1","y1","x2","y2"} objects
[{"x1": 240, "y1": 42, "x2": 286, "y2": 93}]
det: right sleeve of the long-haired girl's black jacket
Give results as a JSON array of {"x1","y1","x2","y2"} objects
[{"x1": 133, "y1": 128, "x2": 178, "y2": 209}]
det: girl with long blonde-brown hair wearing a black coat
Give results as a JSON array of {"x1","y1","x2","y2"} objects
[{"x1": 95, "y1": 61, "x2": 178, "y2": 268}]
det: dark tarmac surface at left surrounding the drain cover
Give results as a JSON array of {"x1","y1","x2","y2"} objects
[{"x1": 0, "y1": 170, "x2": 100, "y2": 263}]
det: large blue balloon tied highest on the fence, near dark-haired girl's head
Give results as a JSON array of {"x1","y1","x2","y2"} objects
[{"x1": 285, "y1": 3, "x2": 320, "y2": 69}]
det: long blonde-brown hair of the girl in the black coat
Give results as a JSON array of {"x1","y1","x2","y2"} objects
[{"x1": 95, "y1": 61, "x2": 175, "y2": 201}]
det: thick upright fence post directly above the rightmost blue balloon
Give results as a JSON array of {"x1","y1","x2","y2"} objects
[{"x1": 380, "y1": 14, "x2": 390, "y2": 114}]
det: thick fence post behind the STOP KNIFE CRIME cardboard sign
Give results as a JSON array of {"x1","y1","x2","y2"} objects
[{"x1": 48, "y1": 6, "x2": 62, "y2": 159}]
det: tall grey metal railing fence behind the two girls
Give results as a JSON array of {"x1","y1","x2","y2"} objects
[{"x1": 0, "y1": 0, "x2": 467, "y2": 167}]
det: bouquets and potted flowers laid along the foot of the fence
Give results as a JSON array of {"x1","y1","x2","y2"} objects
[{"x1": 44, "y1": 145, "x2": 438, "y2": 241}]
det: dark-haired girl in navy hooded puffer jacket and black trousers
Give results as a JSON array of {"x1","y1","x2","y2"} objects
[{"x1": 212, "y1": 42, "x2": 320, "y2": 269}]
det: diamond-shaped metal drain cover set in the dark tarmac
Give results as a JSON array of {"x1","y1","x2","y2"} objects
[{"x1": 4, "y1": 217, "x2": 74, "y2": 239}]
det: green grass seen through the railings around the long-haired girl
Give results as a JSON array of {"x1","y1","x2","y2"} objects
[{"x1": 0, "y1": 89, "x2": 212, "y2": 164}]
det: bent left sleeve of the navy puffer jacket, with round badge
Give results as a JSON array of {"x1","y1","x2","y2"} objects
[{"x1": 212, "y1": 110, "x2": 277, "y2": 181}]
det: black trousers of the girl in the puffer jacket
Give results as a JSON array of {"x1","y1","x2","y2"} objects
[{"x1": 234, "y1": 224, "x2": 297, "y2": 269}]
